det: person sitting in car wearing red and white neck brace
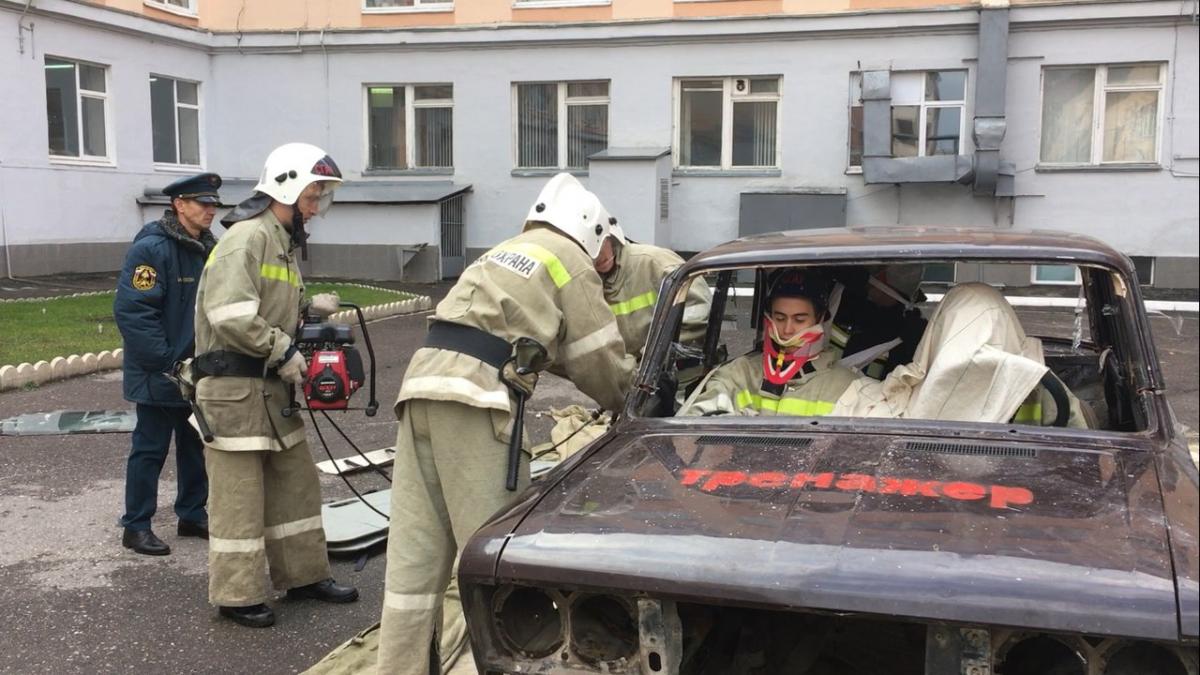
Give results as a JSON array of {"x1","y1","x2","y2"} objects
[{"x1": 678, "y1": 269, "x2": 858, "y2": 417}]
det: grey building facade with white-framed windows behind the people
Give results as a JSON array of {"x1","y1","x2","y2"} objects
[{"x1": 0, "y1": 0, "x2": 1200, "y2": 288}]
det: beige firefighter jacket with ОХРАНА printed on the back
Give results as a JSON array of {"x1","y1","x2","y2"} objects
[{"x1": 396, "y1": 226, "x2": 635, "y2": 416}]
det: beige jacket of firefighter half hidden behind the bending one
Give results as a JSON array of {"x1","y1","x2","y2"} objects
[{"x1": 602, "y1": 243, "x2": 713, "y2": 359}]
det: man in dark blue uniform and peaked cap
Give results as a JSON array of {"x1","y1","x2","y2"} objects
[{"x1": 113, "y1": 173, "x2": 221, "y2": 555}]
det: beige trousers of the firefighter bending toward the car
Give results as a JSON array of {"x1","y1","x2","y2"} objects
[{"x1": 378, "y1": 399, "x2": 529, "y2": 675}]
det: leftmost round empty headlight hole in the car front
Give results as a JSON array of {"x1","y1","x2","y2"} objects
[{"x1": 492, "y1": 586, "x2": 563, "y2": 658}]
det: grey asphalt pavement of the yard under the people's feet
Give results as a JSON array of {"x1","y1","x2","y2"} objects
[{"x1": 0, "y1": 275, "x2": 1200, "y2": 674}]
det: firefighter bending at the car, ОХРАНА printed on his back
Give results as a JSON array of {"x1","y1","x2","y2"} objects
[{"x1": 378, "y1": 173, "x2": 635, "y2": 675}]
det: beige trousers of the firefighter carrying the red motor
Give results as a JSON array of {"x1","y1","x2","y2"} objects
[{"x1": 204, "y1": 441, "x2": 329, "y2": 607}]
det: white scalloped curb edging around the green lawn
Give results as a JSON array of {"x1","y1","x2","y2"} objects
[{"x1": 0, "y1": 283, "x2": 433, "y2": 392}]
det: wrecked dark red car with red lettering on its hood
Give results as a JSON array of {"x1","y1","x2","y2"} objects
[{"x1": 460, "y1": 228, "x2": 1200, "y2": 675}]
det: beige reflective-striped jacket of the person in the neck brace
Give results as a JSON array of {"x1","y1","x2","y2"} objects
[{"x1": 678, "y1": 352, "x2": 858, "y2": 417}]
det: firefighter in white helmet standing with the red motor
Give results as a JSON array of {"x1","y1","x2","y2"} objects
[{"x1": 191, "y1": 143, "x2": 358, "y2": 627}]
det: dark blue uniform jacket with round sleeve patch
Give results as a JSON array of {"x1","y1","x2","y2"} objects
[{"x1": 113, "y1": 210, "x2": 216, "y2": 407}]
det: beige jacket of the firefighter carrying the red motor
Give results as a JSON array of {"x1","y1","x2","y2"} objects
[{"x1": 196, "y1": 209, "x2": 305, "y2": 450}]
